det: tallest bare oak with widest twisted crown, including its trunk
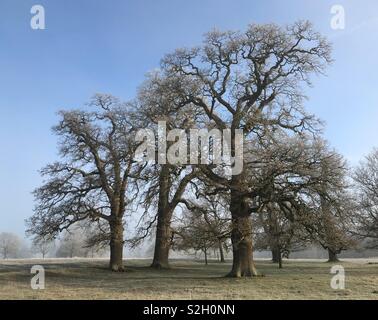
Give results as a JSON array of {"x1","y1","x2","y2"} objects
[{"x1": 162, "y1": 22, "x2": 331, "y2": 277}]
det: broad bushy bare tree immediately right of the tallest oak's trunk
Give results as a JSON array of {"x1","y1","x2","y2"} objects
[{"x1": 247, "y1": 132, "x2": 353, "y2": 264}]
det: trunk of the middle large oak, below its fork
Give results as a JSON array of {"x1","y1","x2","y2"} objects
[{"x1": 151, "y1": 208, "x2": 172, "y2": 269}]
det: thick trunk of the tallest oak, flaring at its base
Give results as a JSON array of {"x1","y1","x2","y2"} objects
[{"x1": 228, "y1": 192, "x2": 257, "y2": 278}]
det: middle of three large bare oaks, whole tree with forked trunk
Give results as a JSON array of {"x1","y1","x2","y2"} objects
[{"x1": 137, "y1": 72, "x2": 202, "y2": 269}]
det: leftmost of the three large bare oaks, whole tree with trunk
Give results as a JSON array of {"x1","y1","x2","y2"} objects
[{"x1": 27, "y1": 95, "x2": 140, "y2": 271}]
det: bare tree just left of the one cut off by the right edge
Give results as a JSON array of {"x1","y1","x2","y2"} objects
[{"x1": 280, "y1": 140, "x2": 355, "y2": 262}]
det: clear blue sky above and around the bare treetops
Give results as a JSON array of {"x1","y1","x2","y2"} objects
[{"x1": 0, "y1": 0, "x2": 378, "y2": 235}]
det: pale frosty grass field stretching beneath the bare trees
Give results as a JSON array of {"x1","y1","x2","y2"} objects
[{"x1": 0, "y1": 259, "x2": 378, "y2": 300}]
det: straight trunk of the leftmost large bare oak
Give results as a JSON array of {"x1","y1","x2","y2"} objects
[{"x1": 109, "y1": 220, "x2": 124, "y2": 272}]
